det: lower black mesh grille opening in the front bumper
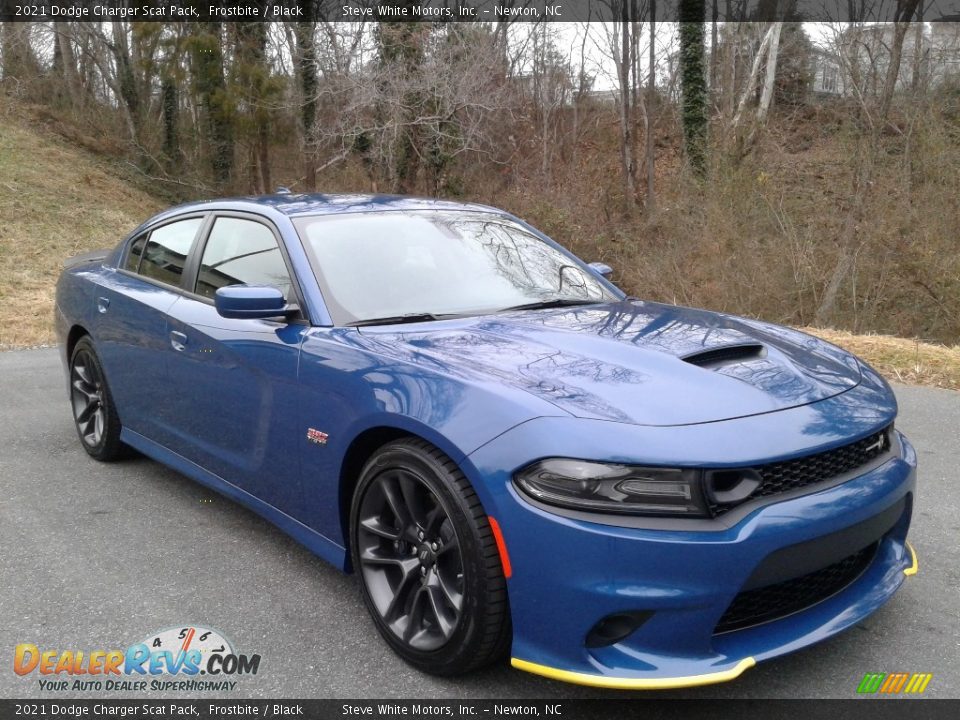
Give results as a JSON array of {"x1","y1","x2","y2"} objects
[{"x1": 714, "y1": 543, "x2": 878, "y2": 635}]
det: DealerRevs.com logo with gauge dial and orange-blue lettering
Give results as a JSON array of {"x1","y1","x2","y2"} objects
[{"x1": 13, "y1": 625, "x2": 260, "y2": 692}]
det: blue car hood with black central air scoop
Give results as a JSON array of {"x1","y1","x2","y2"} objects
[{"x1": 361, "y1": 301, "x2": 861, "y2": 425}]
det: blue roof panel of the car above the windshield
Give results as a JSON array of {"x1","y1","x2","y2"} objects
[{"x1": 155, "y1": 193, "x2": 505, "y2": 219}]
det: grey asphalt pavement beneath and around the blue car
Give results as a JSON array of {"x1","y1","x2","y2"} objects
[{"x1": 0, "y1": 349, "x2": 960, "y2": 700}]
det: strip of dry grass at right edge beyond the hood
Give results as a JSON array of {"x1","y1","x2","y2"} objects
[{"x1": 803, "y1": 328, "x2": 960, "y2": 390}]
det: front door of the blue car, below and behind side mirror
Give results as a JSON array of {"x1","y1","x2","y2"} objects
[{"x1": 167, "y1": 213, "x2": 309, "y2": 516}]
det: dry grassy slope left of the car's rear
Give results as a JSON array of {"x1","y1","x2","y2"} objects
[{"x1": 0, "y1": 101, "x2": 164, "y2": 350}]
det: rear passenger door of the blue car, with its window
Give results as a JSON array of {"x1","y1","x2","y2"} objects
[{"x1": 93, "y1": 214, "x2": 204, "y2": 445}]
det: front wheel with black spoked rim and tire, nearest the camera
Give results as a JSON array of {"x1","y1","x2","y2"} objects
[{"x1": 350, "y1": 439, "x2": 511, "y2": 675}]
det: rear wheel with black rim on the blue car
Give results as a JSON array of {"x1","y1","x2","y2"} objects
[{"x1": 70, "y1": 336, "x2": 126, "y2": 462}]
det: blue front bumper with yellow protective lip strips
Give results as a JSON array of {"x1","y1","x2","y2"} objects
[{"x1": 471, "y1": 420, "x2": 917, "y2": 689}]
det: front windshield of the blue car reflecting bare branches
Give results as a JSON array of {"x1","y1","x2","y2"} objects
[{"x1": 294, "y1": 211, "x2": 618, "y2": 325}]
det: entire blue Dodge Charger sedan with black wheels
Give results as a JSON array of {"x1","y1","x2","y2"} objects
[{"x1": 56, "y1": 194, "x2": 917, "y2": 688}]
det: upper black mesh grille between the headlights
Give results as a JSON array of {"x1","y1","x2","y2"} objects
[{"x1": 710, "y1": 426, "x2": 893, "y2": 515}]
